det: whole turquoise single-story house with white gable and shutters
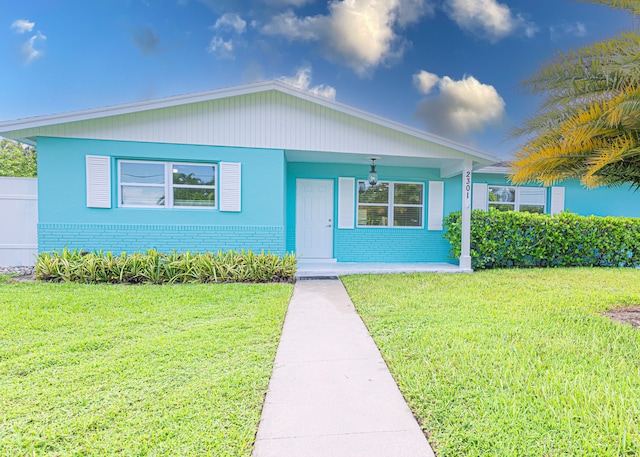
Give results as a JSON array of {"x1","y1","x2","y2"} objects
[{"x1": 0, "y1": 81, "x2": 640, "y2": 270}]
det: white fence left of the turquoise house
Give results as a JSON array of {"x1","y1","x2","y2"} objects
[{"x1": 0, "y1": 178, "x2": 38, "y2": 266}]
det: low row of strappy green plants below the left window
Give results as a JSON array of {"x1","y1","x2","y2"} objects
[{"x1": 36, "y1": 249, "x2": 296, "y2": 284}]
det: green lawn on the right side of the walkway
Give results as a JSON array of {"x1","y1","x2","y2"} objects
[{"x1": 343, "y1": 269, "x2": 640, "y2": 457}]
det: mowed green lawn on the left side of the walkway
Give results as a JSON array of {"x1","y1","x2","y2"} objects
[{"x1": 0, "y1": 281, "x2": 292, "y2": 456}]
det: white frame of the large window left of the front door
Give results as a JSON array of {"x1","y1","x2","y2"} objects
[{"x1": 118, "y1": 160, "x2": 219, "y2": 210}]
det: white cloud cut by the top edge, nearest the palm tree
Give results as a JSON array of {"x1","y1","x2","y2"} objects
[{"x1": 445, "y1": 0, "x2": 537, "y2": 42}]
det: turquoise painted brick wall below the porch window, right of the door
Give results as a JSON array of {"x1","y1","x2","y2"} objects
[{"x1": 334, "y1": 228, "x2": 453, "y2": 262}]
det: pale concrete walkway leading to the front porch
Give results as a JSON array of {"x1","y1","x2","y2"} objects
[{"x1": 253, "y1": 280, "x2": 434, "y2": 457}]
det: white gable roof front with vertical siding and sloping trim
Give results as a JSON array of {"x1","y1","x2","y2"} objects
[{"x1": 0, "y1": 81, "x2": 498, "y2": 172}]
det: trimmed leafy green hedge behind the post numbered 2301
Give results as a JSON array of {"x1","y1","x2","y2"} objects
[{"x1": 444, "y1": 209, "x2": 640, "y2": 269}]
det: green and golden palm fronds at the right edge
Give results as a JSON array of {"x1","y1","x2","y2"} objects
[{"x1": 511, "y1": 0, "x2": 640, "y2": 188}]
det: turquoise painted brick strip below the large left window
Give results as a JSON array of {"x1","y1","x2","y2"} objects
[{"x1": 38, "y1": 224, "x2": 285, "y2": 254}]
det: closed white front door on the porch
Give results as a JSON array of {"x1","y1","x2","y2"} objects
[{"x1": 296, "y1": 179, "x2": 333, "y2": 259}]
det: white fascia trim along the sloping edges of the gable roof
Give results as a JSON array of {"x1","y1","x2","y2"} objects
[{"x1": 0, "y1": 80, "x2": 499, "y2": 164}]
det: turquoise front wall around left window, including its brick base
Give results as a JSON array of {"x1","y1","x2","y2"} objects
[{"x1": 38, "y1": 138, "x2": 285, "y2": 254}]
